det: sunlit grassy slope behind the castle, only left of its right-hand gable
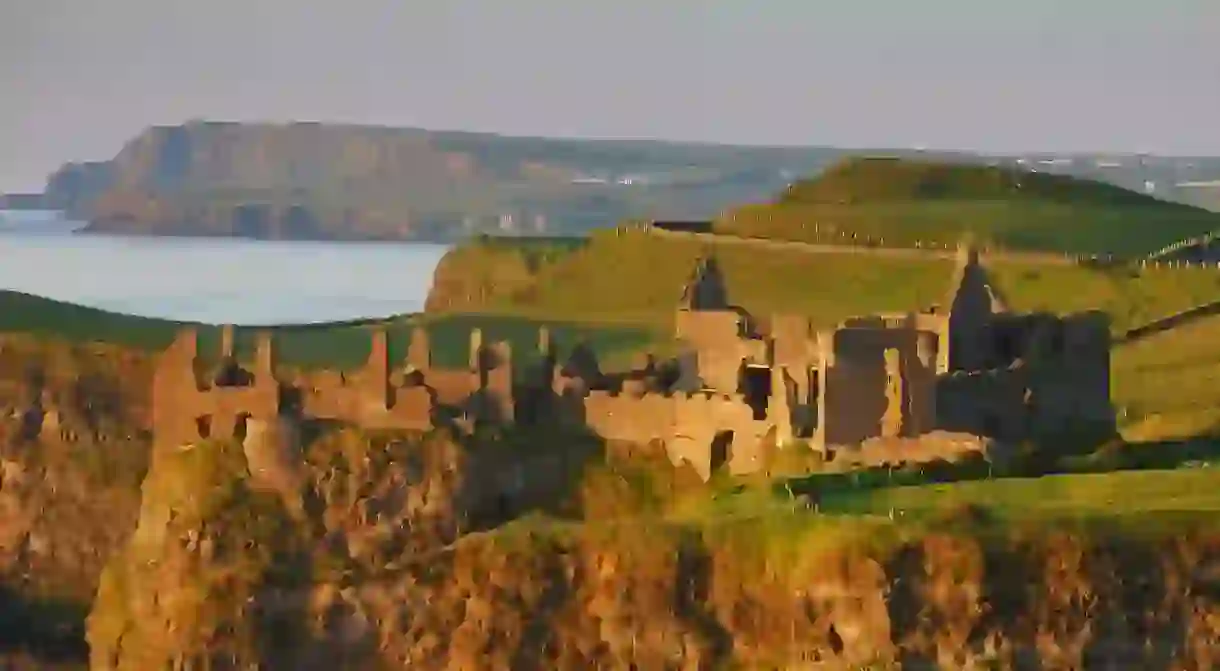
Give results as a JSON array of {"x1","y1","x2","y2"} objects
[{"x1": 427, "y1": 227, "x2": 953, "y2": 333}]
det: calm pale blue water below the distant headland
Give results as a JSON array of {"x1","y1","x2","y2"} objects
[{"x1": 0, "y1": 211, "x2": 448, "y2": 325}]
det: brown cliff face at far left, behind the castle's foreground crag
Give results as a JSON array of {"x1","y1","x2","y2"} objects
[{"x1": 0, "y1": 334, "x2": 150, "y2": 669}]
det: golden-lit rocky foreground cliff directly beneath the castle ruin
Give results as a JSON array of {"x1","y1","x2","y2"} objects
[{"x1": 81, "y1": 419, "x2": 1220, "y2": 670}]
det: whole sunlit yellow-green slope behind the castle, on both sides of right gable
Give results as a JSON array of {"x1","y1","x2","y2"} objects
[{"x1": 439, "y1": 229, "x2": 1220, "y2": 333}]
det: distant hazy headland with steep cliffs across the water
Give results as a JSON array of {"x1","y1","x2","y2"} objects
[{"x1": 21, "y1": 122, "x2": 827, "y2": 242}]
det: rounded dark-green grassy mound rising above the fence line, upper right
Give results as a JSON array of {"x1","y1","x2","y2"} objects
[{"x1": 716, "y1": 159, "x2": 1220, "y2": 256}]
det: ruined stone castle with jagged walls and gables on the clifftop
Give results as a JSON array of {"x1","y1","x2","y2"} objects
[{"x1": 153, "y1": 245, "x2": 1114, "y2": 478}]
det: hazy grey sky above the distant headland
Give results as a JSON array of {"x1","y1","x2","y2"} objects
[{"x1": 0, "y1": 0, "x2": 1220, "y2": 190}]
